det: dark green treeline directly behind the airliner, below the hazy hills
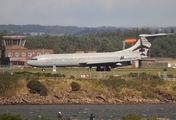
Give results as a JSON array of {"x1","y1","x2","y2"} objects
[{"x1": 0, "y1": 28, "x2": 176, "y2": 58}]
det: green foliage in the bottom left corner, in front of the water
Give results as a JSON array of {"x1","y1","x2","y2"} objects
[{"x1": 0, "y1": 113, "x2": 28, "y2": 120}]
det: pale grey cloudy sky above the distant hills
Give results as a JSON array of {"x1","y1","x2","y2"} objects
[{"x1": 0, "y1": 0, "x2": 176, "y2": 27}]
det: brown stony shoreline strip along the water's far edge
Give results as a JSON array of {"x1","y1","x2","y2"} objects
[{"x1": 0, "y1": 94, "x2": 176, "y2": 105}]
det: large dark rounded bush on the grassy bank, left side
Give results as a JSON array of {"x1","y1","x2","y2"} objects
[{"x1": 27, "y1": 80, "x2": 47, "y2": 96}]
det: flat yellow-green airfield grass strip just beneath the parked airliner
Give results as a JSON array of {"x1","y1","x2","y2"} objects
[{"x1": 8, "y1": 67, "x2": 176, "y2": 78}]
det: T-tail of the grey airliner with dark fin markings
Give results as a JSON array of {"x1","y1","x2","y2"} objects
[{"x1": 123, "y1": 33, "x2": 173, "y2": 58}]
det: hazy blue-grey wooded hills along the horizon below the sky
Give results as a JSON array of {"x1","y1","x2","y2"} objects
[{"x1": 0, "y1": 24, "x2": 176, "y2": 36}]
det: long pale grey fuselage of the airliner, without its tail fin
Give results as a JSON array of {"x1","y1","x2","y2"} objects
[{"x1": 28, "y1": 52, "x2": 140, "y2": 67}]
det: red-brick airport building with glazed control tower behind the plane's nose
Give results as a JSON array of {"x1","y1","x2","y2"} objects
[{"x1": 0, "y1": 36, "x2": 53, "y2": 67}]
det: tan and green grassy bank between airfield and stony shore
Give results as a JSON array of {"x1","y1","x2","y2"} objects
[{"x1": 0, "y1": 69, "x2": 176, "y2": 100}]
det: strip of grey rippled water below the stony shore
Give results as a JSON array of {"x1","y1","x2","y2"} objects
[{"x1": 0, "y1": 104, "x2": 176, "y2": 120}]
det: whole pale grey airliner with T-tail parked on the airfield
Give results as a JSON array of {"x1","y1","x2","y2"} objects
[{"x1": 27, "y1": 33, "x2": 171, "y2": 71}]
